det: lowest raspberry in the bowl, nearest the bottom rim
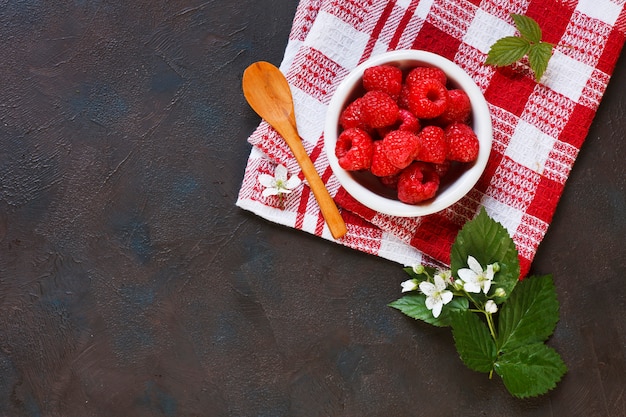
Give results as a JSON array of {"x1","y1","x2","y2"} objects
[{"x1": 398, "y1": 162, "x2": 439, "y2": 204}]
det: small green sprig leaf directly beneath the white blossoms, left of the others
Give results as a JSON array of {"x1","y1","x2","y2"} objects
[{"x1": 452, "y1": 310, "x2": 496, "y2": 372}]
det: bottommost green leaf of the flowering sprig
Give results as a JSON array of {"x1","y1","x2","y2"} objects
[{"x1": 494, "y1": 343, "x2": 567, "y2": 398}]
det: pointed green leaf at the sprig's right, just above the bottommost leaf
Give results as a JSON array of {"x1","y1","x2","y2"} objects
[{"x1": 498, "y1": 275, "x2": 559, "y2": 353}]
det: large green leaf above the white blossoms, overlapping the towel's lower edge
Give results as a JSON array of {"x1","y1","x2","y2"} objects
[{"x1": 450, "y1": 208, "x2": 520, "y2": 304}]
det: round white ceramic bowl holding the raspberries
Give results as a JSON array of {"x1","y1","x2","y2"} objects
[{"x1": 324, "y1": 50, "x2": 493, "y2": 217}]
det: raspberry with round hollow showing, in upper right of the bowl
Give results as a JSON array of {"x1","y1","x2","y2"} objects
[{"x1": 407, "y1": 78, "x2": 450, "y2": 119}]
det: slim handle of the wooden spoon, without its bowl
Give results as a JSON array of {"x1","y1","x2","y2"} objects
[{"x1": 274, "y1": 123, "x2": 347, "y2": 239}]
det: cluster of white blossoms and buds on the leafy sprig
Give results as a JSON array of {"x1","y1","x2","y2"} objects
[{"x1": 401, "y1": 255, "x2": 504, "y2": 318}]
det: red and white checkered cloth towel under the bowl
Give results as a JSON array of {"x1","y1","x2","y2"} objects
[{"x1": 237, "y1": 0, "x2": 626, "y2": 277}]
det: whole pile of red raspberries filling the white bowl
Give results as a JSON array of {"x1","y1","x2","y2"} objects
[{"x1": 335, "y1": 65, "x2": 479, "y2": 204}]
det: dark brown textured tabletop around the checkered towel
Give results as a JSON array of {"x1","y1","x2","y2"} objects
[{"x1": 0, "y1": 0, "x2": 626, "y2": 417}]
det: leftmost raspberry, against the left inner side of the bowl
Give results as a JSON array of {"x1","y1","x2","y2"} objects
[{"x1": 335, "y1": 128, "x2": 374, "y2": 171}]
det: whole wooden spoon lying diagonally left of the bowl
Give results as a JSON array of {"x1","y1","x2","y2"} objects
[{"x1": 243, "y1": 61, "x2": 347, "y2": 239}]
